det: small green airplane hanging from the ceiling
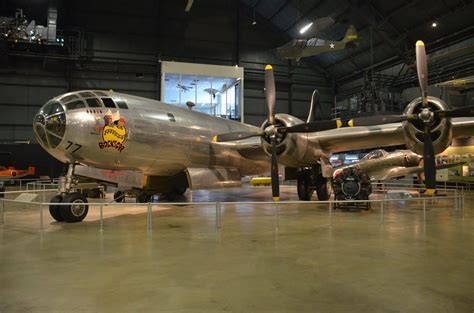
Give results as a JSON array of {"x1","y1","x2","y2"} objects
[{"x1": 276, "y1": 25, "x2": 358, "y2": 61}]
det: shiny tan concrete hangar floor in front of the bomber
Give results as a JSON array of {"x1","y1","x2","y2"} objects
[{"x1": 0, "y1": 187, "x2": 474, "y2": 313}]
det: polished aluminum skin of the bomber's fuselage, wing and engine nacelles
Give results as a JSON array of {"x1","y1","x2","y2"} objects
[{"x1": 33, "y1": 91, "x2": 474, "y2": 181}]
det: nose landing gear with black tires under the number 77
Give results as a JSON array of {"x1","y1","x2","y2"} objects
[{"x1": 49, "y1": 164, "x2": 89, "y2": 223}]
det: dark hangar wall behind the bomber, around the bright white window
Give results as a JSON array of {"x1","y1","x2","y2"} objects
[{"x1": 0, "y1": 0, "x2": 333, "y2": 142}]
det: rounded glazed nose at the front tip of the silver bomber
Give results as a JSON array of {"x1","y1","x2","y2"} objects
[{"x1": 33, "y1": 100, "x2": 66, "y2": 149}]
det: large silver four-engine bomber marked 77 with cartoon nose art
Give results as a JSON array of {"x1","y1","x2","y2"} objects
[{"x1": 33, "y1": 42, "x2": 474, "y2": 222}]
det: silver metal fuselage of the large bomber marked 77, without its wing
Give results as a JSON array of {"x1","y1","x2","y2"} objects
[{"x1": 34, "y1": 91, "x2": 269, "y2": 176}]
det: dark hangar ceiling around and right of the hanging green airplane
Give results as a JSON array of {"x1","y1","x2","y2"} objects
[{"x1": 241, "y1": 0, "x2": 474, "y2": 83}]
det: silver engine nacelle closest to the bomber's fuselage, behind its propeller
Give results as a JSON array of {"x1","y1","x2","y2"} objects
[{"x1": 262, "y1": 114, "x2": 321, "y2": 168}]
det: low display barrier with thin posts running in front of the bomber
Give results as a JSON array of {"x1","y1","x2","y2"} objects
[{"x1": 0, "y1": 188, "x2": 465, "y2": 233}]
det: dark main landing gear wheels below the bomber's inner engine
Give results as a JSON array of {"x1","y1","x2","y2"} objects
[{"x1": 296, "y1": 166, "x2": 330, "y2": 201}]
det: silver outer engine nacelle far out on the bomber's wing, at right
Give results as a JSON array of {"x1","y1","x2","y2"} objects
[{"x1": 403, "y1": 97, "x2": 453, "y2": 155}]
